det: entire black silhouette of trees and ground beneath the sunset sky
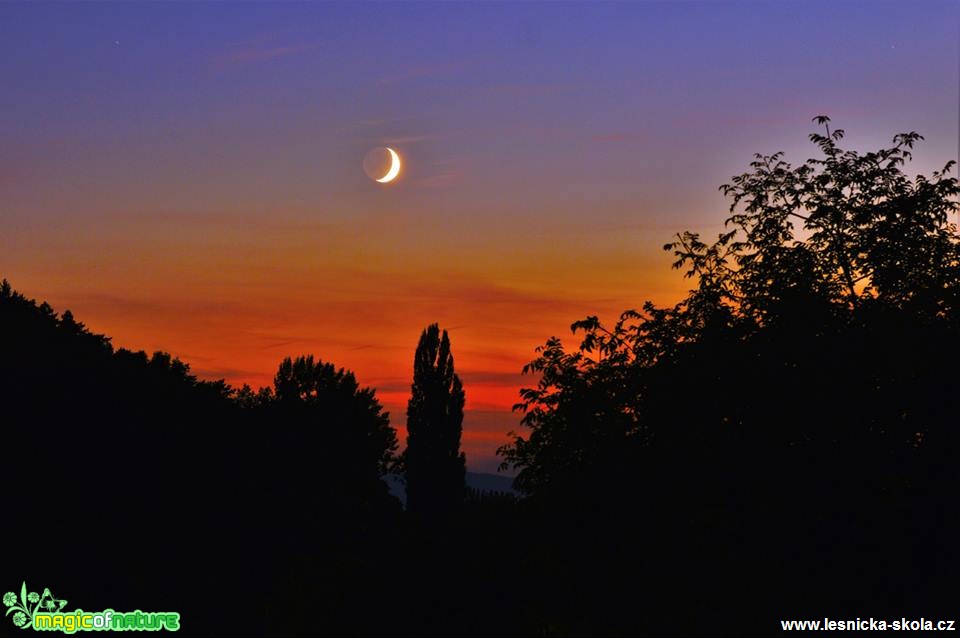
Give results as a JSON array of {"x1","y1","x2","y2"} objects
[{"x1": 0, "y1": 117, "x2": 960, "y2": 636}]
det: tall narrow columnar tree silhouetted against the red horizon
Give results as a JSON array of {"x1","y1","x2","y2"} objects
[{"x1": 404, "y1": 324, "x2": 466, "y2": 515}]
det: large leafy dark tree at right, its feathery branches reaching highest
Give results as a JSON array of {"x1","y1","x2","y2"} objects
[{"x1": 500, "y1": 118, "x2": 960, "y2": 634}]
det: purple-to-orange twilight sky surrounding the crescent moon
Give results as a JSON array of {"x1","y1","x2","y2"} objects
[{"x1": 0, "y1": 1, "x2": 960, "y2": 471}]
